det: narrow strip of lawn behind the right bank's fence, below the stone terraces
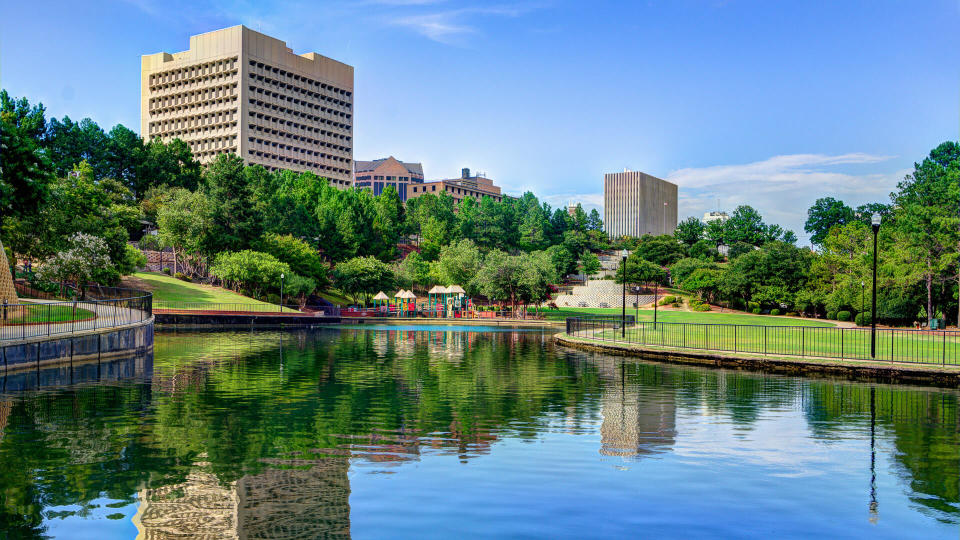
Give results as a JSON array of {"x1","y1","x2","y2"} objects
[{"x1": 543, "y1": 308, "x2": 836, "y2": 327}]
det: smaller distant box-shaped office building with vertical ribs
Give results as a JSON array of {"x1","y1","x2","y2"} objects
[{"x1": 603, "y1": 171, "x2": 677, "y2": 238}]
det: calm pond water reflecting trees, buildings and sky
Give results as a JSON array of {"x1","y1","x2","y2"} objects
[{"x1": 0, "y1": 327, "x2": 960, "y2": 539}]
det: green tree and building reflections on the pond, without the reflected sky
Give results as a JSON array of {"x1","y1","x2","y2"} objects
[{"x1": 0, "y1": 329, "x2": 960, "y2": 538}]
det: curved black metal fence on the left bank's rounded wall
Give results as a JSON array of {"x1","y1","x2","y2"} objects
[{"x1": 0, "y1": 286, "x2": 153, "y2": 340}]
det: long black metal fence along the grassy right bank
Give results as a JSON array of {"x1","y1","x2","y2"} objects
[{"x1": 567, "y1": 317, "x2": 960, "y2": 365}]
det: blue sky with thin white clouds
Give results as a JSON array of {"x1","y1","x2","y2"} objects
[{"x1": 0, "y1": 0, "x2": 960, "y2": 243}]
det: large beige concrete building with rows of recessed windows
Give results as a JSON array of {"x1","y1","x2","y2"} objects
[{"x1": 140, "y1": 26, "x2": 353, "y2": 187}]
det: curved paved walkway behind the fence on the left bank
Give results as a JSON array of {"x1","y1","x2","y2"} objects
[{"x1": 0, "y1": 300, "x2": 150, "y2": 341}]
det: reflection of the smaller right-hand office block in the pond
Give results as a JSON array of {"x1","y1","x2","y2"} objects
[{"x1": 597, "y1": 358, "x2": 677, "y2": 458}]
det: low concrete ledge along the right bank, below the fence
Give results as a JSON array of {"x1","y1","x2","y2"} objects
[{"x1": 554, "y1": 333, "x2": 960, "y2": 388}]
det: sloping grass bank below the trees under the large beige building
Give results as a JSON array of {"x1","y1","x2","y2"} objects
[{"x1": 126, "y1": 272, "x2": 295, "y2": 312}]
